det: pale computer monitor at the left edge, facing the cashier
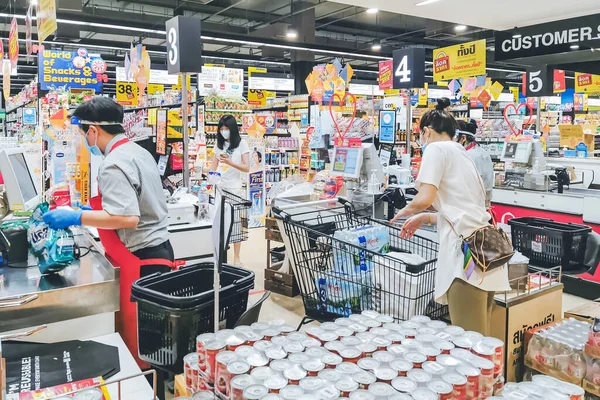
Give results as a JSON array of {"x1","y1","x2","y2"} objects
[{"x1": 0, "y1": 148, "x2": 40, "y2": 211}]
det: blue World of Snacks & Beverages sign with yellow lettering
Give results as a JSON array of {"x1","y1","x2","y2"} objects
[{"x1": 38, "y1": 48, "x2": 106, "y2": 93}]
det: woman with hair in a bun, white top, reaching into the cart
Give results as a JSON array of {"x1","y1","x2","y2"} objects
[{"x1": 392, "y1": 110, "x2": 510, "y2": 335}]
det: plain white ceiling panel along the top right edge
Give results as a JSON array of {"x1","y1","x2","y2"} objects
[{"x1": 334, "y1": 0, "x2": 600, "y2": 30}]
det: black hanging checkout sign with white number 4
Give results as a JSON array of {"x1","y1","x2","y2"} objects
[{"x1": 393, "y1": 48, "x2": 425, "y2": 89}]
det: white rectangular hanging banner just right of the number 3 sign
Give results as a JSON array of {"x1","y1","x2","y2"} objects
[{"x1": 198, "y1": 66, "x2": 244, "y2": 97}]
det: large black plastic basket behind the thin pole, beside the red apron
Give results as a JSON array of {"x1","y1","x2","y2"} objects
[{"x1": 132, "y1": 263, "x2": 254, "y2": 374}]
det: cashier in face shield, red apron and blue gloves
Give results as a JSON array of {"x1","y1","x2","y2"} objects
[{"x1": 44, "y1": 96, "x2": 174, "y2": 368}]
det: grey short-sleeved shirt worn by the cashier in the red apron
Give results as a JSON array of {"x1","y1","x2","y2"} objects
[{"x1": 98, "y1": 135, "x2": 169, "y2": 252}]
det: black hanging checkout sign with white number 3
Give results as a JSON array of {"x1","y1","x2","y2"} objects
[{"x1": 166, "y1": 16, "x2": 202, "y2": 75}]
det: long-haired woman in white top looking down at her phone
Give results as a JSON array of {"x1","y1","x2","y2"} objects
[{"x1": 210, "y1": 115, "x2": 250, "y2": 266}]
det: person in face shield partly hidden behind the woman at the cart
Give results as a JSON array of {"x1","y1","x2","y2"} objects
[{"x1": 456, "y1": 119, "x2": 494, "y2": 209}]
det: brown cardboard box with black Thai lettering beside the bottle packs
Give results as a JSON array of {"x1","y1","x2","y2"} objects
[{"x1": 491, "y1": 284, "x2": 563, "y2": 382}]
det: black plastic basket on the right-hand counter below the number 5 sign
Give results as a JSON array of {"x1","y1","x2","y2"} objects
[{"x1": 508, "y1": 217, "x2": 592, "y2": 271}]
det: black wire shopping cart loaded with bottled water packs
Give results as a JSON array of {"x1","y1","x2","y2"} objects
[{"x1": 273, "y1": 199, "x2": 447, "y2": 326}]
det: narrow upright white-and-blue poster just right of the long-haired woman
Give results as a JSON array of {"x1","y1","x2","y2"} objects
[{"x1": 248, "y1": 138, "x2": 266, "y2": 228}]
